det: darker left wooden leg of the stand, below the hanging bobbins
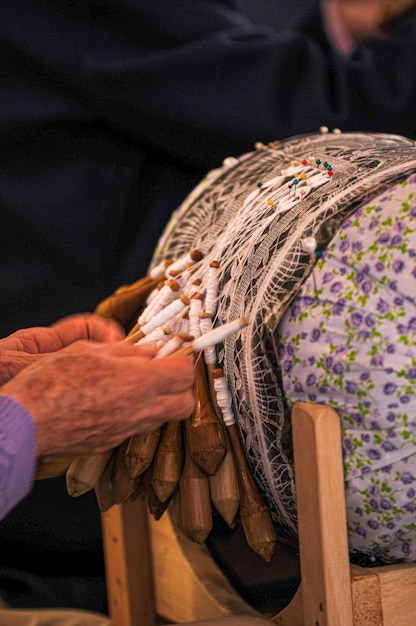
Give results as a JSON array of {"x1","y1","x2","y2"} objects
[{"x1": 102, "y1": 497, "x2": 155, "y2": 626}]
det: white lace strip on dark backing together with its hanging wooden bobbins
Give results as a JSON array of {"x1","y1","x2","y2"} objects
[{"x1": 60, "y1": 127, "x2": 416, "y2": 560}]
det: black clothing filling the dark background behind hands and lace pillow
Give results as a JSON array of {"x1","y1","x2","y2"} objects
[{"x1": 0, "y1": 0, "x2": 416, "y2": 611}]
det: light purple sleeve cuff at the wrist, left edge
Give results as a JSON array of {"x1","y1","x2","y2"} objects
[{"x1": 0, "y1": 395, "x2": 36, "y2": 519}]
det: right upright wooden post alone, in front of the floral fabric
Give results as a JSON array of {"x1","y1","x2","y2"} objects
[{"x1": 292, "y1": 402, "x2": 353, "y2": 626}]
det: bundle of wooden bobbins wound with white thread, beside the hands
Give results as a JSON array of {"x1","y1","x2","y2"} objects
[{"x1": 66, "y1": 249, "x2": 277, "y2": 561}]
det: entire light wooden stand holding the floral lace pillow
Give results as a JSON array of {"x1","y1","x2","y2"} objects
[{"x1": 103, "y1": 403, "x2": 416, "y2": 626}]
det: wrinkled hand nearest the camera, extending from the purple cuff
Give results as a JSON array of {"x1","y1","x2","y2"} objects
[{"x1": 1, "y1": 338, "x2": 194, "y2": 456}]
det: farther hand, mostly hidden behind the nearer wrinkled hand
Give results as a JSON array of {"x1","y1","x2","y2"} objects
[{"x1": 0, "y1": 313, "x2": 124, "y2": 385}]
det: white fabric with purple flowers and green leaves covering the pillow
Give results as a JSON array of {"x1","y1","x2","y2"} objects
[{"x1": 278, "y1": 175, "x2": 416, "y2": 562}]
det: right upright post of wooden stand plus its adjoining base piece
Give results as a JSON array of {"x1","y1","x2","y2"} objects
[{"x1": 272, "y1": 402, "x2": 416, "y2": 626}]
